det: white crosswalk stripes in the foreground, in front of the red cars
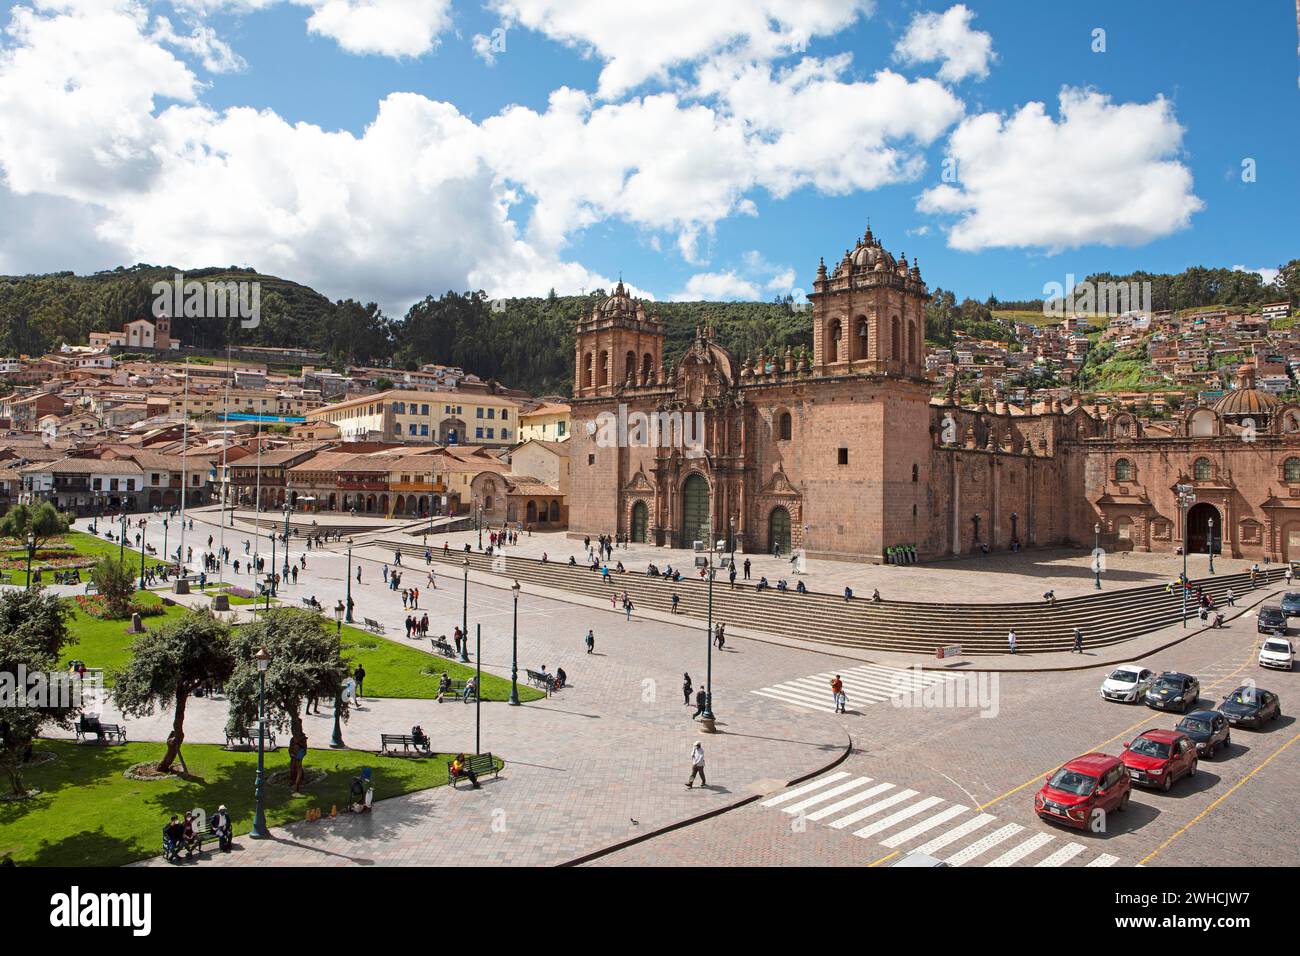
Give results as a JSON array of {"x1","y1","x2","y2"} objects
[{"x1": 761, "y1": 770, "x2": 1119, "y2": 869}]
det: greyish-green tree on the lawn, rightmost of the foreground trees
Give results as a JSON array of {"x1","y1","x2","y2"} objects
[{"x1": 226, "y1": 607, "x2": 348, "y2": 791}]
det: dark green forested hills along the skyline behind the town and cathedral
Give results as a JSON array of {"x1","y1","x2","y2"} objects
[{"x1": 0, "y1": 259, "x2": 1300, "y2": 394}]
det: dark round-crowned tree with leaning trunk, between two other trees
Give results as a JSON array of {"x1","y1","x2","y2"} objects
[{"x1": 113, "y1": 609, "x2": 235, "y2": 774}]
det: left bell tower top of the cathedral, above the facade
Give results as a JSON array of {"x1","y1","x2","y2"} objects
[{"x1": 573, "y1": 280, "x2": 663, "y2": 398}]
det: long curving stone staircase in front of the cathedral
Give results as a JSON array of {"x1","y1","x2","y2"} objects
[{"x1": 376, "y1": 540, "x2": 1284, "y2": 656}]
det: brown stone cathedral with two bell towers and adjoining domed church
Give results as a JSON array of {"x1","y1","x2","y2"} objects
[{"x1": 569, "y1": 228, "x2": 1300, "y2": 561}]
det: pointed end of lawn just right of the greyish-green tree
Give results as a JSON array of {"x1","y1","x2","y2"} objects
[{"x1": 343, "y1": 624, "x2": 543, "y2": 701}]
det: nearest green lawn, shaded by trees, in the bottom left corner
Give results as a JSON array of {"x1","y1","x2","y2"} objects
[{"x1": 0, "y1": 740, "x2": 475, "y2": 866}]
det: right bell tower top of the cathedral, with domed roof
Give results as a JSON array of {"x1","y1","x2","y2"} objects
[{"x1": 809, "y1": 226, "x2": 930, "y2": 378}]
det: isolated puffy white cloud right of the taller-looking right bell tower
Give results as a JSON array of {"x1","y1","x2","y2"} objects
[{"x1": 917, "y1": 88, "x2": 1204, "y2": 251}]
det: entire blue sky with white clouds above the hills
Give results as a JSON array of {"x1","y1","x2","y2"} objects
[{"x1": 0, "y1": 0, "x2": 1300, "y2": 313}]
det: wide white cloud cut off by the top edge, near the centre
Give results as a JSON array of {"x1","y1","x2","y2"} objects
[{"x1": 490, "y1": 0, "x2": 874, "y2": 99}]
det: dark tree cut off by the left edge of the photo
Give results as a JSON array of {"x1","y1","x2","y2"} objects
[{"x1": 0, "y1": 591, "x2": 79, "y2": 796}]
